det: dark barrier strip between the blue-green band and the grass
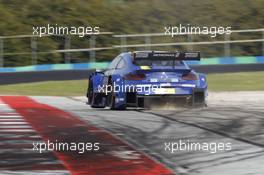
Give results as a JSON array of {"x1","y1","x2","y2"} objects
[{"x1": 0, "y1": 64, "x2": 264, "y2": 85}]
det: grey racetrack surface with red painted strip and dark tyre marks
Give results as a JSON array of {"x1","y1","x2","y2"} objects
[{"x1": 0, "y1": 92, "x2": 264, "y2": 175}]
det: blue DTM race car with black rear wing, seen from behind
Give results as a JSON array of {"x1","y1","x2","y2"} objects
[{"x1": 87, "y1": 51, "x2": 207, "y2": 109}]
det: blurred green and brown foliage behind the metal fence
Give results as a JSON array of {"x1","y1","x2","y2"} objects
[{"x1": 0, "y1": 0, "x2": 264, "y2": 66}]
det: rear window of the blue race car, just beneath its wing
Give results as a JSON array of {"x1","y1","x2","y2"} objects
[{"x1": 134, "y1": 59, "x2": 185, "y2": 68}]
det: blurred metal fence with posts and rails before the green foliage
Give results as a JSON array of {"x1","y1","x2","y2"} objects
[{"x1": 0, "y1": 28, "x2": 264, "y2": 67}]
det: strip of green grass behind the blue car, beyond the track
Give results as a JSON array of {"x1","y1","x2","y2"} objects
[{"x1": 0, "y1": 71, "x2": 264, "y2": 96}]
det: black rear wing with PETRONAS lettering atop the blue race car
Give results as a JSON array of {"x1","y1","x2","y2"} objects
[{"x1": 133, "y1": 51, "x2": 201, "y2": 61}]
